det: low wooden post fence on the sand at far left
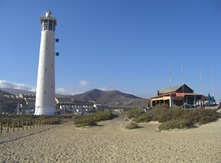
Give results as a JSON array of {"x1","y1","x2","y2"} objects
[{"x1": 0, "y1": 117, "x2": 58, "y2": 135}]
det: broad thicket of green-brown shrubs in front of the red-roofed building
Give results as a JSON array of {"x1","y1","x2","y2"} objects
[{"x1": 127, "y1": 105, "x2": 221, "y2": 130}]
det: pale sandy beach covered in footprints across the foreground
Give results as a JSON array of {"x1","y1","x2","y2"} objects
[{"x1": 0, "y1": 116, "x2": 221, "y2": 163}]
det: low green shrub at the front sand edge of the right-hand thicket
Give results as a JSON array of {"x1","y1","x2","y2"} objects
[{"x1": 158, "y1": 119, "x2": 193, "y2": 131}]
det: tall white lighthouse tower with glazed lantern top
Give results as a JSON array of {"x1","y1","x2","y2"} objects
[{"x1": 34, "y1": 10, "x2": 58, "y2": 115}]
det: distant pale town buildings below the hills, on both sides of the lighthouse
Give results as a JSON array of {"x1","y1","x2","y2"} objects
[{"x1": 0, "y1": 89, "x2": 110, "y2": 115}]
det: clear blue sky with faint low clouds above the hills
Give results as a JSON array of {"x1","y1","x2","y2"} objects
[{"x1": 0, "y1": 0, "x2": 221, "y2": 100}]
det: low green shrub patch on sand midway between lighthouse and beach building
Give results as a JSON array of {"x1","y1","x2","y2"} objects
[{"x1": 74, "y1": 111, "x2": 116, "y2": 127}]
